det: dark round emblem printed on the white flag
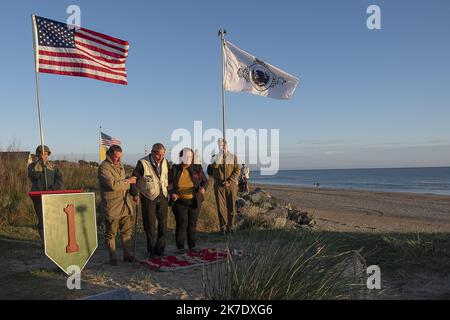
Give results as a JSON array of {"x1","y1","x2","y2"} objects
[{"x1": 238, "y1": 59, "x2": 286, "y2": 92}]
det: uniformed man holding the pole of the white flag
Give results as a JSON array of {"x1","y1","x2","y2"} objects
[{"x1": 211, "y1": 139, "x2": 240, "y2": 233}]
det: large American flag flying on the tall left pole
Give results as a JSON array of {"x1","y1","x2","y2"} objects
[{"x1": 33, "y1": 16, "x2": 129, "y2": 85}]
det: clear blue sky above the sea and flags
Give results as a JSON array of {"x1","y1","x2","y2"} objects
[{"x1": 0, "y1": 0, "x2": 450, "y2": 169}]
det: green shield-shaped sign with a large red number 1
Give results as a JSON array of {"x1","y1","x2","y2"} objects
[{"x1": 42, "y1": 193, "x2": 98, "y2": 274}]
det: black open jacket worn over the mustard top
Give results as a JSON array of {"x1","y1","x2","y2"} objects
[{"x1": 169, "y1": 164, "x2": 208, "y2": 207}]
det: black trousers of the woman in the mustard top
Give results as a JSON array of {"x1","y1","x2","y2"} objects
[{"x1": 172, "y1": 199, "x2": 200, "y2": 249}]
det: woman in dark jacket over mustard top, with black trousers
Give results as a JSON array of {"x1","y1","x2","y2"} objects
[{"x1": 169, "y1": 148, "x2": 208, "y2": 253}]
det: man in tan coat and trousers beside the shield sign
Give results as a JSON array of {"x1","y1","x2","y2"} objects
[{"x1": 98, "y1": 145, "x2": 136, "y2": 266}]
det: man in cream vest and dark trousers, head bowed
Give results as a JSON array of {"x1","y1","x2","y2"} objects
[{"x1": 131, "y1": 143, "x2": 170, "y2": 258}]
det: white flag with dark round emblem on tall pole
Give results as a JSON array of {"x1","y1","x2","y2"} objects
[{"x1": 223, "y1": 41, "x2": 299, "y2": 99}]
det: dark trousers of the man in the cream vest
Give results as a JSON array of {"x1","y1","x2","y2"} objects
[{"x1": 141, "y1": 194, "x2": 168, "y2": 255}]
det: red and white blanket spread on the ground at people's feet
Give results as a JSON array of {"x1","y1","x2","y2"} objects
[{"x1": 142, "y1": 249, "x2": 228, "y2": 271}]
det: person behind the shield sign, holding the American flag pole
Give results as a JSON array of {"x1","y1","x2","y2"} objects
[{"x1": 28, "y1": 146, "x2": 63, "y2": 243}]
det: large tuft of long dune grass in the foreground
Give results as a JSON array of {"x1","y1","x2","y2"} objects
[{"x1": 203, "y1": 230, "x2": 368, "y2": 300}]
